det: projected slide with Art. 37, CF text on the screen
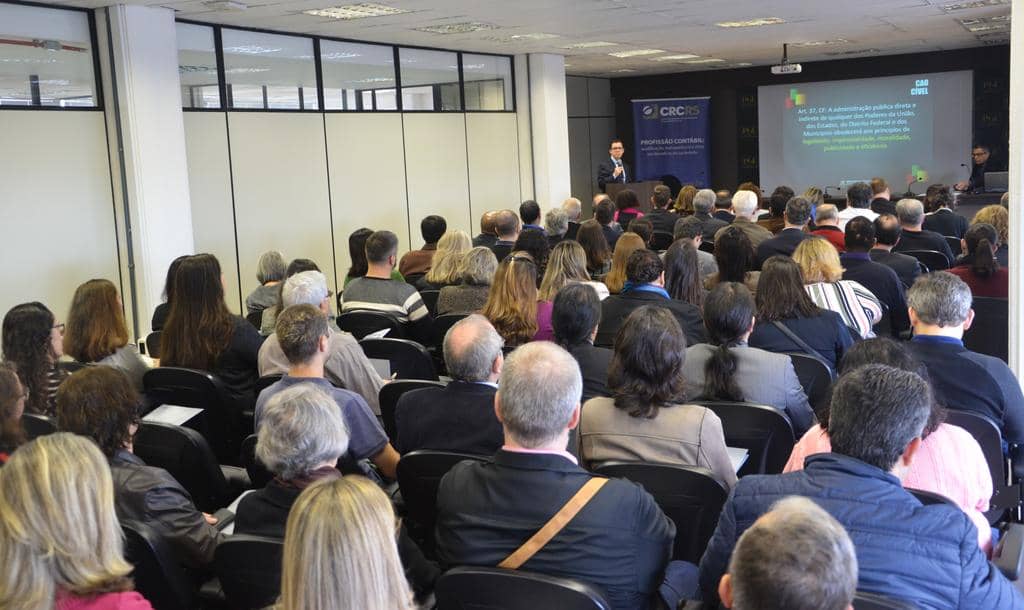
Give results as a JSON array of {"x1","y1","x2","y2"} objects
[{"x1": 758, "y1": 71, "x2": 972, "y2": 195}]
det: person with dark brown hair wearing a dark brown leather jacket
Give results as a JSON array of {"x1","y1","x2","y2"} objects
[{"x1": 57, "y1": 366, "x2": 220, "y2": 568}]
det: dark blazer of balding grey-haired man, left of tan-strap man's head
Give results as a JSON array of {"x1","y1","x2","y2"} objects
[{"x1": 394, "y1": 381, "x2": 505, "y2": 455}]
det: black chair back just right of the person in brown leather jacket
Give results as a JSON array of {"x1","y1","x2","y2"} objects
[{"x1": 133, "y1": 420, "x2": 250, "y2": 513}]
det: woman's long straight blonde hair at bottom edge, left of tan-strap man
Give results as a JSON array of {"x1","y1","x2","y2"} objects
[{"x1": 276, "y1": 476, "x2": 416, "y2": 610}]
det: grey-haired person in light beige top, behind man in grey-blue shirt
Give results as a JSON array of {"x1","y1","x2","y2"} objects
[{"x1": 257, "y1": 271, "x2": 384, "y2": 415}]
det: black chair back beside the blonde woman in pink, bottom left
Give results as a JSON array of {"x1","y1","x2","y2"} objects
[{"x1": 121, "y1": 521, "x2": 195, "y2": 610}]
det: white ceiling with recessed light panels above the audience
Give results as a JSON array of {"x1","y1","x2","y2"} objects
[{"x1": 34, "y1": 0, "x2": 1010, "y2": 77}]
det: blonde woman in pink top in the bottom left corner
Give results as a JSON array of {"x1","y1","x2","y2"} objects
[{"x1": 0, "y1": 434, "x2": 153, "y2": 610}]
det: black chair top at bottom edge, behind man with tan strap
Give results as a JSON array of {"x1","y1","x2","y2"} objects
[{"x1": 434, "y1": 567, "x2": 611, "y2": 610}]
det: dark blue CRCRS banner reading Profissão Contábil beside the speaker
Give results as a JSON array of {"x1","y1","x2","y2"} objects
[{"x1": 633, "y1": 97, "x2": 711, "y2": 188}]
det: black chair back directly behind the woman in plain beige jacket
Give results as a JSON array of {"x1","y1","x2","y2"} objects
[{"x1": 593, "y1": 462, "x2": 729, "y2": 564}]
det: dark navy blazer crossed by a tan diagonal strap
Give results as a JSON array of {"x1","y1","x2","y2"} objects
[{"x1": 437, "y1": 450, "x2": 676, "y2": 610}]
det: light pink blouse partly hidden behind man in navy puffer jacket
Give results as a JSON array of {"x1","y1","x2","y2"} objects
[{"x1": 782, "y1": 424, "x2": 992, "y2": 553}]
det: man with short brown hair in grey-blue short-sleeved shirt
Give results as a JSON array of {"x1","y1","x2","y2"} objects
[{"x1": 255, "y1": 304, "x2": 398, "y2": 479}]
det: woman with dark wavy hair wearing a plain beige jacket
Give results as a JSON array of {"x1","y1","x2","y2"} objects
[{"x1": 580, "y1": 305, "x2": 736, "y2": 488}]
